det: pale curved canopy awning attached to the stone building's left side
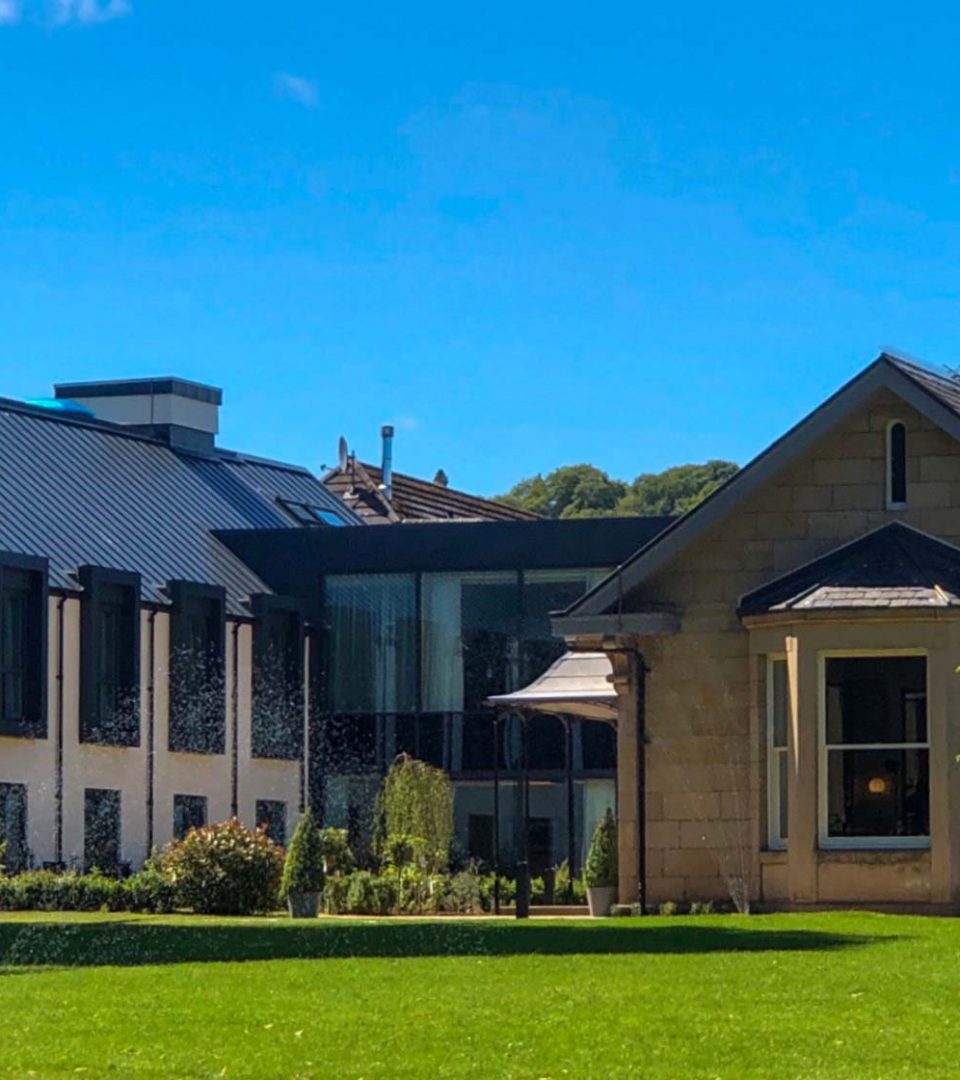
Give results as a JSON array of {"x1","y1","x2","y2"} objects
[{"x1": 486, "y1": 652, "x2": 617, "y2": 723}]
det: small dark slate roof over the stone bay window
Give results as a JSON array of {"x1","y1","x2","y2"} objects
[{"x1": 739, "y1": 522, "x2": 960, "y2": 616}]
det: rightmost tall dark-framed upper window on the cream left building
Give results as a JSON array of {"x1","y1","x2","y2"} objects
[{"x1": 252, "y1": 596, "x2": 303, "y2": 760}]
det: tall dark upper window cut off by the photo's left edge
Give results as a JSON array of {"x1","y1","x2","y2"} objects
[{"x1": 0, "y1": 556, "x2": 46, "y2": 739}]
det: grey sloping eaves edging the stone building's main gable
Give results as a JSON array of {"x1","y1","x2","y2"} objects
[{"x1": 553, "y1": 352, "x2": 960, "y2": 617}]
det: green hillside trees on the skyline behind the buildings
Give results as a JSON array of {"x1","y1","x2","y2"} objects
[{"x1": 498, "y1": 461, "x2": 738, "y2": 517}]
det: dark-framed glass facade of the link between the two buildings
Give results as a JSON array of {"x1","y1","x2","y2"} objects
[{"x1": 320, "y1": 570, "x2": 616, "y2": 858}]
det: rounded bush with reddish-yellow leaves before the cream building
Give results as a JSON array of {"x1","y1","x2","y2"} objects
[{"x1": 161, "y1": 818, "x2": 283, "y2": 915}]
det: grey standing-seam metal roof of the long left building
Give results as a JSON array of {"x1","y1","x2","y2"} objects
[{"x1": 0, "y1": 399, "x2": 357, "y2": 613}]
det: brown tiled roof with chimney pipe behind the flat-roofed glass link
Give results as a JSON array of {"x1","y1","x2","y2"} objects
[{"x1": 323, "y1": 461, "x2": 539, "y2": 525}]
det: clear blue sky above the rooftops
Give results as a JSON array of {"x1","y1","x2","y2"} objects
[{"x1": 0, "y1": 0, "x2": 960, "y2": 492}]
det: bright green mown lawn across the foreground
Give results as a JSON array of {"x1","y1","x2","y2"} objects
[{"x1": 0, "y1": 914, "x2": 960, "y2": 1080}]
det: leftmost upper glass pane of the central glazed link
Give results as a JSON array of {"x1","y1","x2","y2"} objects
[{"x1": 325, "y1": 573, "x2": 417, "y2": 713}]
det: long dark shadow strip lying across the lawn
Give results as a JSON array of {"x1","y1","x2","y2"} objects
[{"x1": 0, "y1": 919, "x2": 890, "y2": 973}]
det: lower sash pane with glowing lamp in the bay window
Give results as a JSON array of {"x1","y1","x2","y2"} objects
[{"x1": 827, "y1": 750, "x2": 930, "y2": 837}]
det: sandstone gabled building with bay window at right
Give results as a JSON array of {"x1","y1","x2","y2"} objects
[{"x1": 553, "y1": 354, "x2": 960, "y2": 909}]
